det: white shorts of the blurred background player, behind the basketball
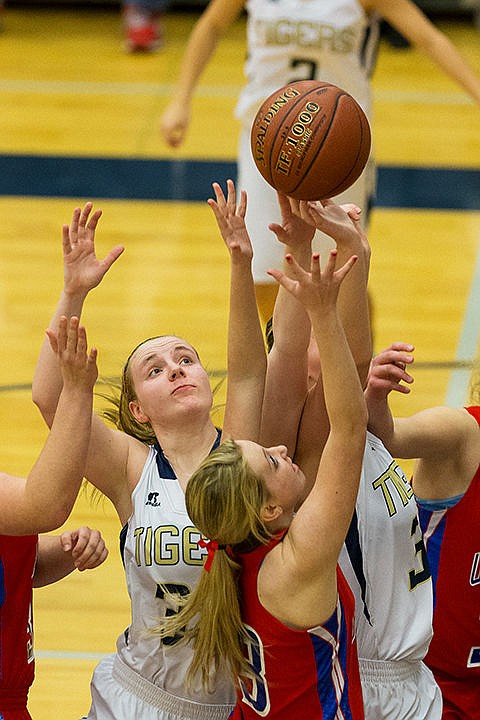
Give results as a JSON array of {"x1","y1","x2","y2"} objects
[{"x1": 237, "y1": 127, "x2": 375, "y2": 283}]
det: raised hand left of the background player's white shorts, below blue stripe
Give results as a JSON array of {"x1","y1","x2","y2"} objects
[{"x1": 208, "y1": 180, "x2": 253, "y2": 261}]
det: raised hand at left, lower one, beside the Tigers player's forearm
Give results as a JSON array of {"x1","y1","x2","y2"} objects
[{"x1": 46, "y1": 315, "x2": 98, "y2": 391}]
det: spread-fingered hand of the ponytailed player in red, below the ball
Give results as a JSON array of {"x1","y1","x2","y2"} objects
[{"x1": 268, "y1": 250, "x2": 358, "y2": 311}]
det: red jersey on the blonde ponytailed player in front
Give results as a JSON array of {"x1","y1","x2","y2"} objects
[{"x1": 231, "y1": 538, "x2": 364, "y2": 720}]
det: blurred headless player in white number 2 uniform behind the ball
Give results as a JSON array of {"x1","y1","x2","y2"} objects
[{"x1": 161, "y1": 0, "x2": 480, "y2": 322}]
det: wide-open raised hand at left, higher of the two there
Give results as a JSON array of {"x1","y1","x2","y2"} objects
[{"x1": 62, "y1": 202, "x2": 124, "y2": 293}]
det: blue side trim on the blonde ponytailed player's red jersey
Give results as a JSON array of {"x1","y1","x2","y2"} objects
[{"x1": 310, "y1": 605, "x2": 352, "y2": 720}]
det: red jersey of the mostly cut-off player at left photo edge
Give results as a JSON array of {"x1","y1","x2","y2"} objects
[{"x1": 0, "y1": 535, "x2": 38, "y2": 720}]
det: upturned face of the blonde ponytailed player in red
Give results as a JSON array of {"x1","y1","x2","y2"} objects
[{"x1": 238, "y1": 440, "x2": 307, "y2": 517}]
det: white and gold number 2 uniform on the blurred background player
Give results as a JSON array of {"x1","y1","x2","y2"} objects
[{"x1": 236, "y1": 0, "x2": 379, "y2": 284}]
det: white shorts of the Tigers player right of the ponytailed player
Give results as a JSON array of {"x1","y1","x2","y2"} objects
[{"x1": 359, "y1": 658, "x2": 442, "y2": 720}]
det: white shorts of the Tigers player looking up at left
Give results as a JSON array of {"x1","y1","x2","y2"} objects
[{"x1": 87, "y1": 655, "x2": 233, "y2": 720}]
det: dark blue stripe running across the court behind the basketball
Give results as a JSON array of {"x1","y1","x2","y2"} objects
[{"x1": 0, "y1": 155, "x2": 480, "y2": 210}]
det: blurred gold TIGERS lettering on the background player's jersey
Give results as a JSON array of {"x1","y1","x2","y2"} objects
[{"x1": 252, "y1": 18, "x2": 356, "y2": 53}]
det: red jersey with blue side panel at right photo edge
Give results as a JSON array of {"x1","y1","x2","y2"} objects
[{"x1": 418, "y1": 406, "x2": 480, "y2": 720}]
